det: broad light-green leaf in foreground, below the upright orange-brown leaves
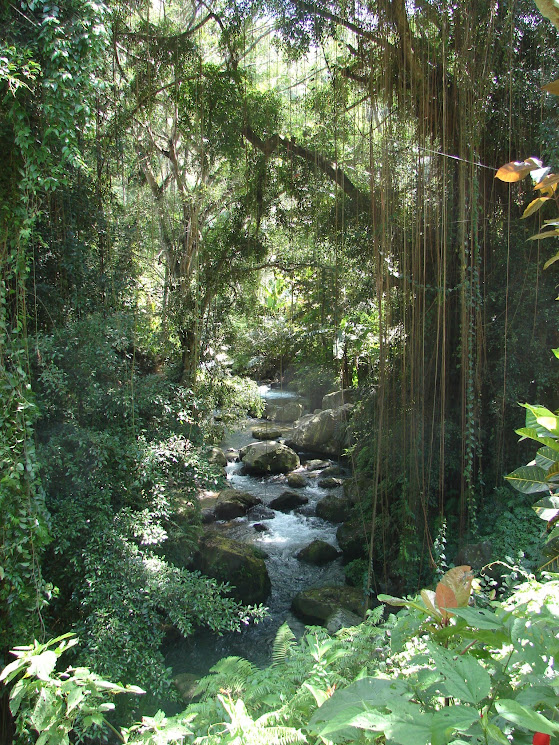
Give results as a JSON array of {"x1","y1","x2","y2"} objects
[{"x1": 429, "y1": 644, "x2": 491, "y2": 704}]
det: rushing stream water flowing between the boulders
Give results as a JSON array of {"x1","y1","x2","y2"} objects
[{"x1": 166, "y1": 386, "x2": 345, "y2": 676}]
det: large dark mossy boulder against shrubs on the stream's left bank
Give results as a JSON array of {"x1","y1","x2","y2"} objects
[{"x1": 193, "y1": 531, "x2": 272, "y2": 605}]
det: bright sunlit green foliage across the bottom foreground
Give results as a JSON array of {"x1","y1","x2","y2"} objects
[{"x1": 3, "y1": 568, "x2": 559, "y2": 745}]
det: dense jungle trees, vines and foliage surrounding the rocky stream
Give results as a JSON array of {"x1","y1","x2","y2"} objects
[{"x1": 0, "y1": 0, "x2": 559, "y2": 745}]
